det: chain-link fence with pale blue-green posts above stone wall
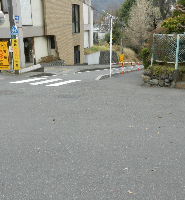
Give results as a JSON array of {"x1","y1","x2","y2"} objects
[{"x1": 151, "y1": 33, "x2": 185, "y2": 69}]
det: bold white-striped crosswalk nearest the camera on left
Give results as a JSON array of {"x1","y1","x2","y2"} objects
[{"x1": 10, "y1": 77, "x2": 81, "y2": 87}]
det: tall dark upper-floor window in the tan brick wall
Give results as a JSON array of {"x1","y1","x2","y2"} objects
[{"x1": 72, "y1": 4, "x2": 80, "y2": 33}]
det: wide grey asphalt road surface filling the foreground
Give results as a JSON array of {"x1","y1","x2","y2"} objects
[{"x1": 0, "y1": 65, "x2": 185, "y2": 200}]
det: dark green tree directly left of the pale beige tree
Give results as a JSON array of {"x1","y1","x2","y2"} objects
[{"x1": 119, "y1": 0, "x2": 136, "y2": 25}]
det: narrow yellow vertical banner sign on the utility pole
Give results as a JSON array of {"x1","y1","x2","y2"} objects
[{"x1": 12, "y1": 39, "x2": 20, "y2": 70}]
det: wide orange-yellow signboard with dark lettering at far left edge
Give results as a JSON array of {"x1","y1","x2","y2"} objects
[{"x1": 0, "y1": 41, "x2": 9, "y2": 70}]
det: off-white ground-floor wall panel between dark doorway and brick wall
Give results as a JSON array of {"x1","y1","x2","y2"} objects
[{"x1": 34, "y1": 37, "x2": 48, "y2": 62}]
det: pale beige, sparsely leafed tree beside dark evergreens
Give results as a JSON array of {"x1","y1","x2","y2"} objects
[{"x1": 126, "y1": 0, "x2": 156, "y2": 51}]
